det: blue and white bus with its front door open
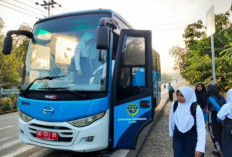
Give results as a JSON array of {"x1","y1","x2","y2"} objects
[{"x1": 3, "y1": 9, "x2": 161, "y2": 152}]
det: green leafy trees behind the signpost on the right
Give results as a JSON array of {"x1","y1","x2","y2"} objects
[{"x1": 170, "y1": 12, "x2": 232, "y2": 90}]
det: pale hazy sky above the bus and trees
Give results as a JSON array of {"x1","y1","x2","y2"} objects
[{"x1": 0, "y1": 0, "x2": 231, "y2": 73}]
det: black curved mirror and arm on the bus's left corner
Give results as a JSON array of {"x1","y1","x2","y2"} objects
[{"x1": 2, "y1": 30, "x2": 33, "y2": 55}]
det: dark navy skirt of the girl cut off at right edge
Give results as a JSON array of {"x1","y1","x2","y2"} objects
[{"x1": 222, "y1": 118, "x2": 232, "y2": 157}]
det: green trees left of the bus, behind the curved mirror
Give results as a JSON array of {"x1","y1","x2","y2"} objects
[{"x1": 0, "y1": 18, "x2": 32, "y2": 88}]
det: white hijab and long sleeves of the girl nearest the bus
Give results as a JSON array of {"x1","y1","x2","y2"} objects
[{"x1": 169, "y1": 86, "x2": 206, "y2": 153}]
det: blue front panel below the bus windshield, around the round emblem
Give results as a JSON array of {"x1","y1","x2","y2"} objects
[{"x1": 18, "y1": 97, "x2": 109, "y2": 122}]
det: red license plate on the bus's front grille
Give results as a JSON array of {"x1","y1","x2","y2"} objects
[{"x1": 36, "y1": 130, "x2": 58, "y2": 141}]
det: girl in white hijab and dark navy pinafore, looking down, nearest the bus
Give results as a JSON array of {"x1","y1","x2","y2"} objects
[{"x1": 169, "y1": 86, "x2": 206, "y2": 157}]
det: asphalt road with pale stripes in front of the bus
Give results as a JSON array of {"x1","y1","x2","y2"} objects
[{"x1": 0, "y1": 112, "x2": 110, "y2": 157}]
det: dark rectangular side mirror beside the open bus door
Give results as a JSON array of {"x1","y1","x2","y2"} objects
[{"x1": 97, "y1": 26, "x2": 110, "y2": 50}]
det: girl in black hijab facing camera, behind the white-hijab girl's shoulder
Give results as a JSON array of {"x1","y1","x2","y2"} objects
[{"x1": 195, "y1": 82, "x2": 208, "y2": 122}]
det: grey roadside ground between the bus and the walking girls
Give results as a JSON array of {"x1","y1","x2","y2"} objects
[{"x1": 138, "y1": 92, "x2": 216, "y2": 157}]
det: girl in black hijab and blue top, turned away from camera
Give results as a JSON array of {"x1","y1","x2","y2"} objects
[{"x1": 207, "y1": 83, "x2": 226, "y2": 156}]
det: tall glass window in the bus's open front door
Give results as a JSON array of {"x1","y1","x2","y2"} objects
[{"x1": 117, "y1": 37, "x2": 147, "y2": 100}]
